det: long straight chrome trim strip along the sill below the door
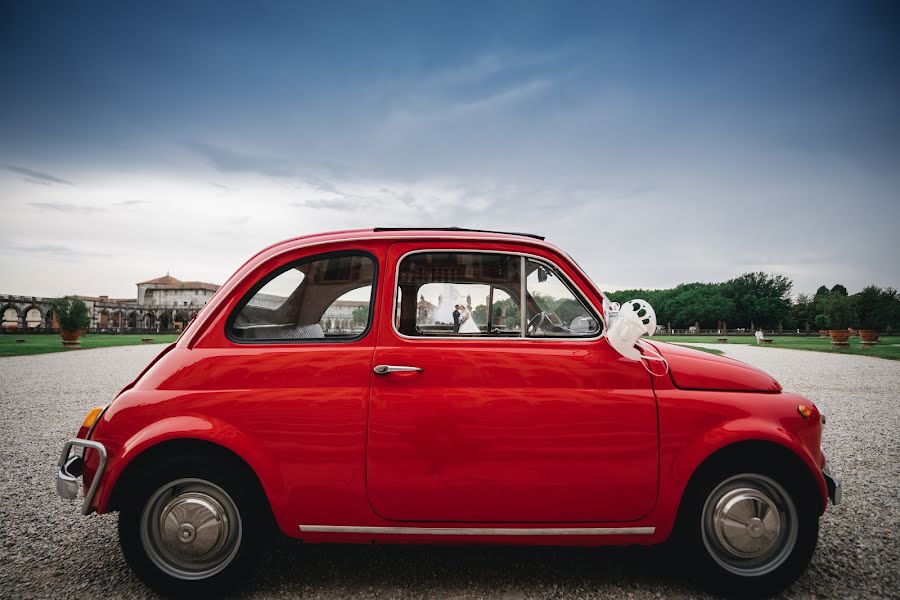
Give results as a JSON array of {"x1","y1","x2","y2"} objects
[{"x1": 300, "y1": 525, "x2": 656, "y2": 536}]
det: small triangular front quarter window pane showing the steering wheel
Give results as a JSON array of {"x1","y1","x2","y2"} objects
[{"x1": 525, "y1": 259, "x2": 600, "y2": 337}]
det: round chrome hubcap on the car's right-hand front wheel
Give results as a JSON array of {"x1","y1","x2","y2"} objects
[{"x1": 701, "y1": 474, "x2": 797, "y2": 576}]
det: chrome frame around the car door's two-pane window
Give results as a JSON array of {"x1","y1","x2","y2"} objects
[{"x1": 391, "y1": 248, "x2": 606, "y2": 342}]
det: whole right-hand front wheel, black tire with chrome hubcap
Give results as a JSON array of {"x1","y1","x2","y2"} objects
[{"x1": 677, "y1": 461, "x2": 819, "y2": 597}]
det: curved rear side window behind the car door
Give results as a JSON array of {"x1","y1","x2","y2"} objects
[{"x1": 228, "y1": 253, "x2": 375, "y2": 342}]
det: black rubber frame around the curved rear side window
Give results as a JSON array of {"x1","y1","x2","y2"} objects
[{"x1": 225, "y1": 250, "x2": 381, "y2": 346}]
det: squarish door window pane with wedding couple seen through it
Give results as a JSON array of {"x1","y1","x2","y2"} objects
[{"x1": 394, "y1": 252, "x2": 521, "y2": 337}]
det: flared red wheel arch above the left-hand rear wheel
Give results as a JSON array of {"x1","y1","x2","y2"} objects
[{"x1": 97, "y1": 415, "x2": 285, "y2": 528}]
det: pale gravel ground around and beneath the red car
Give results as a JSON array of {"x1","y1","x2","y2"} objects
[{"x1": 0, "y1": 346, "x2": 900, "y2": 599}]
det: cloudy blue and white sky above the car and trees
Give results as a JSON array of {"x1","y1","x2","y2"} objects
[{"x1": 0, "y1": 0, "x2": 900, "y2": 298}]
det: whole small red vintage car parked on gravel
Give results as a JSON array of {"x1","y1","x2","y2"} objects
[{"x1": 57, "y1": 228, "x2": 841, "y2": 594}]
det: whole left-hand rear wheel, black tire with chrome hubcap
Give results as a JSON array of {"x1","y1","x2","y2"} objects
[{"x1": 119, "y1": 455, "x2": 274, "y2": 598}]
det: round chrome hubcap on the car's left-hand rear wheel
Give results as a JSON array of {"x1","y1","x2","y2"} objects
[{"x1": 141, "y1": 479, "x2": 241, "y2": 579}]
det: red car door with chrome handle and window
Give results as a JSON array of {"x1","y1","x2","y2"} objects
[{"x1": 366, "y1": 244, "x2": 658, "y2": 523}]
